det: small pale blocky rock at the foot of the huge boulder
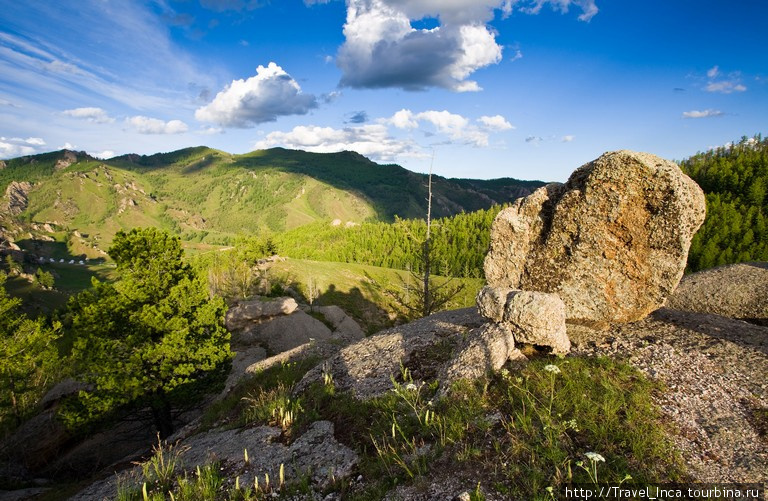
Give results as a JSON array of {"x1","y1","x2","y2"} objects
[{"x1": 504, "y1": 291, "x2": 571, "y2": 354}]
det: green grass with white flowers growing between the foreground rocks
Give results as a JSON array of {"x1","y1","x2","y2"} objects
[{"x1": 195, "y1": 357, "x2": 685, "y2": 499}]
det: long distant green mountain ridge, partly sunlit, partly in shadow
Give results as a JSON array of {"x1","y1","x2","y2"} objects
[{"x1": 0, "y1": 146, "x2": 544, "y2": 252}]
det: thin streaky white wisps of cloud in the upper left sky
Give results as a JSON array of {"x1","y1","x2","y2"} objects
[{"x1": 0, "y1": 0, "x2": 219, "y2": 111}]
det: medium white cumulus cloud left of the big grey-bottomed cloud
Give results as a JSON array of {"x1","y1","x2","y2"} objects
[{"x1": 195, "y1": 62, "x2": 317, "y2": 128}]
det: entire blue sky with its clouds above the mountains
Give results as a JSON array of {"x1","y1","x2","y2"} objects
[{"x1": 0, "y1": 0, "x2": 768, "y2": 181}]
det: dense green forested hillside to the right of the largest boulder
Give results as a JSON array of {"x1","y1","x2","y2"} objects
[{"x1": 681, "y1": 135, "x2": 768, "y2": 271}]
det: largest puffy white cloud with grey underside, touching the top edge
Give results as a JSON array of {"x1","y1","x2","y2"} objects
[{"x1": 336, "y1": 0, "x2": 598, "y2": 92}]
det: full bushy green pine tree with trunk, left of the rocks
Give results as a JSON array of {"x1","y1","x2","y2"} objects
[{"x1": 69, "y1": 228, "x2": 231, "y2": 438}]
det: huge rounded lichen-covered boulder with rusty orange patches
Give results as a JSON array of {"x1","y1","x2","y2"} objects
[{"x1": 485, "y1": 150, "x2": 705, "y2": 327}]
